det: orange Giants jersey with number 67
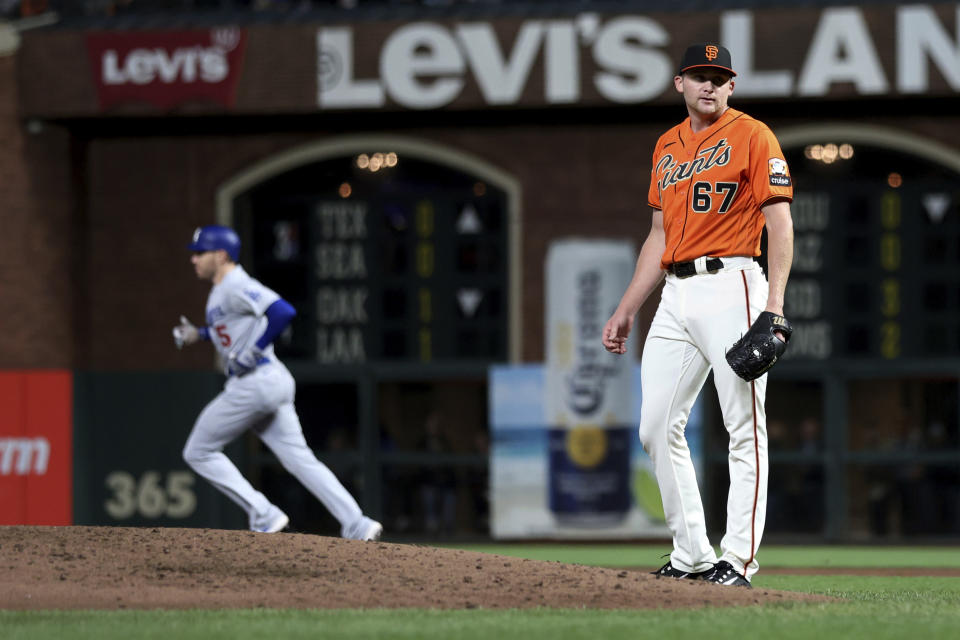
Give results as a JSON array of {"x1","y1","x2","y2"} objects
[{"x1": 648, "y1": 109, "x2": 793, "y2": 268}]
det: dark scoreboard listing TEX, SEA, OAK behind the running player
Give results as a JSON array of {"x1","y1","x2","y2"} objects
[{"x1": 244, "y1": 189, "x2": 509, "y2": 365}]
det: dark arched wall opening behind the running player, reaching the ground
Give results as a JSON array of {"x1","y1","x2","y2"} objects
[{"x1": 218, "y1": 136, "x2": 520, "y2": 536}]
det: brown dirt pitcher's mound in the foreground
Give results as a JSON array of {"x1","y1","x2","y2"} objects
[{"x1": 0, "y1": 527, "x2": 826, "y2": 609}]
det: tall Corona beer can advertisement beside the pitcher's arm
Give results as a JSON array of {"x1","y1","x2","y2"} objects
[{"x1": 543, "y1": 239, "x2": 636, "y2": 528}]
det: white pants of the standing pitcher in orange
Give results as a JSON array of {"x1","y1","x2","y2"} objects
[{"x1": 640, "y1": 259, "x2": 768, "y2": 579}]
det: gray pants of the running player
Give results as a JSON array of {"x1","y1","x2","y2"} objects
[{"x1": 183, "y1": 362, "x2": 363, "y2": 536}]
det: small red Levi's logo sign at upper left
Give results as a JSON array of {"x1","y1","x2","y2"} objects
[{"x1": 87, "y1": 28, "x2": 247, "y2": 110}]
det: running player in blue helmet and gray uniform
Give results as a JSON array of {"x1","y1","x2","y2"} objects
[{"x1": 173, "y1": 225, "x2": 383, "y2": 540}]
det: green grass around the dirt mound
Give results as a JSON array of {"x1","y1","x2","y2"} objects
[{"x1": 0, "y1": 544, "x2": 960, "y2": 640}]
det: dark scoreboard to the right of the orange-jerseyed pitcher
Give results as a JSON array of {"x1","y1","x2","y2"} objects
[{"x1": 784, "y1": 182, "x2": 960, "y2": 360}]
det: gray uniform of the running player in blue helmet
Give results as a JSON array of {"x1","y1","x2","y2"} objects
[{"x1": 183, "y1": 265, "x2": 380, "y2": 539}]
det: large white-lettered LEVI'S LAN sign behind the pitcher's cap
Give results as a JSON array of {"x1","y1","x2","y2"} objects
[{"x1": 317, "y1": 4, "x2": 960, "y2": 109}]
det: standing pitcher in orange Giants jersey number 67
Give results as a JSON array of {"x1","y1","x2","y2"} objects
[{"x1": 603, "y1": 43, "x2": 793, "y2": 587}]
